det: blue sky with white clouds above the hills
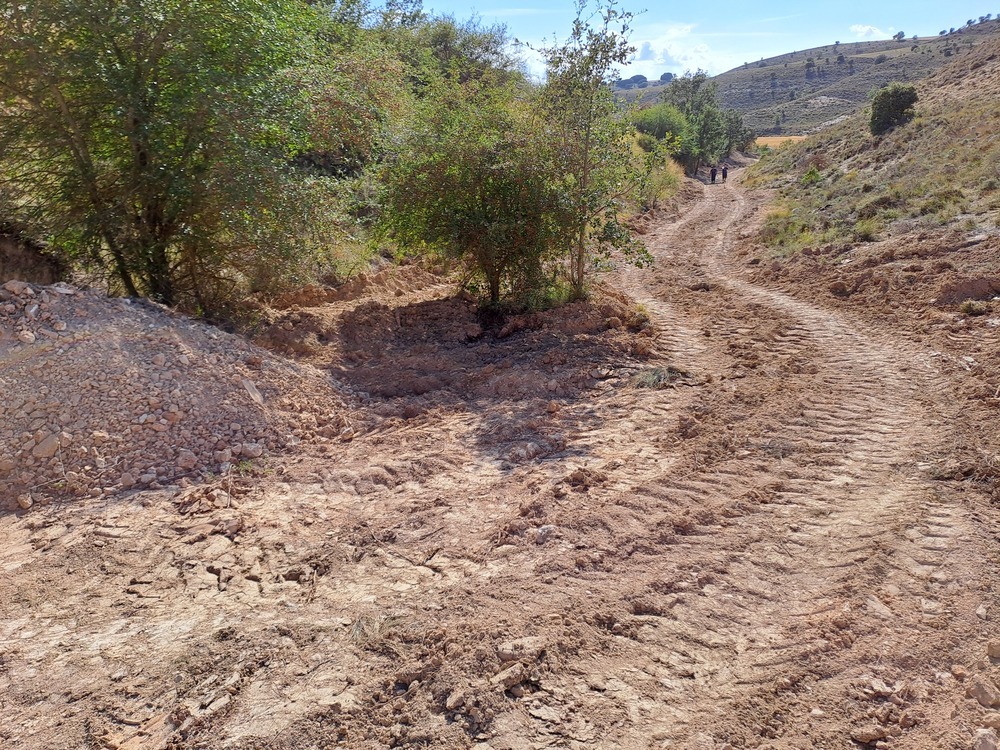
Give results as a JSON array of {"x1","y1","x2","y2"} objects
[{"x1": 424, "y1": 0, "x2": 1000, "y2": 78}]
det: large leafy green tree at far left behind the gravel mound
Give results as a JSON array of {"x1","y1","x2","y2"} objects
[{"x1": 0, "y1": 0, "x2": 371, "y2": 308}]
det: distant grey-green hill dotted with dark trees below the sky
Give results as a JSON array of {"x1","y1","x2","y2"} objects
[{"x1": 625, "y1": 18, "x2": 1000, "y2": 135}]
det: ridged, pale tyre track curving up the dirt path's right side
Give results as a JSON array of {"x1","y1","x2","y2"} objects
[{"x1": 588, "y1": 179, "x2": 989, "y2": 747}]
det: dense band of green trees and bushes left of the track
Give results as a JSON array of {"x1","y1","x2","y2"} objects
[{"x1": 0, "y1": 0, "x2": 735, "y2": 314}]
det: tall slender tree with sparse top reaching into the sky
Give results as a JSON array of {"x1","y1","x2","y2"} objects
[{"x1": 540, "y1": 0, "x2": 654, "y2": 297}]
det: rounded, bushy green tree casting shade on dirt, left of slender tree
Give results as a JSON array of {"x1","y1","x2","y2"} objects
[{"x1": 380, "y1": 76, "x2": 558, "y2": 308}]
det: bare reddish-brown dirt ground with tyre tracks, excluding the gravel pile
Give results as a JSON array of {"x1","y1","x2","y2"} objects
[{"x1": 0, "y1": 172, "x2": 1000, "y2": 750}]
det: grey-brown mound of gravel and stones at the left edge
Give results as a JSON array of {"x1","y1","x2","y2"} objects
[{"x1": 0, "y1": 281, "x2": 352, "y2": 508}]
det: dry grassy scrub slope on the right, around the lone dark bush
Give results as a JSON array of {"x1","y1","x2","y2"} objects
[{"x1": 750, "y1": 37, "x2": 1000, "y2": 254}]
